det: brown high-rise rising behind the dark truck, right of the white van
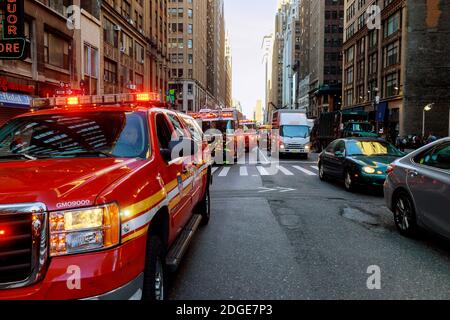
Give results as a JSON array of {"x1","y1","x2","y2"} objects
[{"x1": 308, "y1": 0, "x2": 342, "y2": 117}]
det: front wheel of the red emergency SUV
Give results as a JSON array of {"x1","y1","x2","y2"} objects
[{"x1": 142, "y1": 236, "x2": 166, "y2": 301}]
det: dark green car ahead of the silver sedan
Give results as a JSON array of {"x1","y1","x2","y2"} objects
[{"x1": 319, "y1": 138, "x2": 405, "y2": 191}]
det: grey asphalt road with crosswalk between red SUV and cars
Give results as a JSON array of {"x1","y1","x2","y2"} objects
[{"x1": 170, "y1": 150, "x2": 450, "y2": 300}]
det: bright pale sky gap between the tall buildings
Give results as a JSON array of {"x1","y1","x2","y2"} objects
[{"x1": 224, "y1": 0, "x2": 277, "y2": 118}]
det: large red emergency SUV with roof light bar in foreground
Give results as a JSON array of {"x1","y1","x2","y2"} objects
[{"x1": 0, "y1": 93, "x2": 211, "y2": 300}]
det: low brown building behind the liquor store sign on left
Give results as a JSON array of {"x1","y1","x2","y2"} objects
[{"x1": 0, "y1": 0, "x2": 100, "y2": 124}]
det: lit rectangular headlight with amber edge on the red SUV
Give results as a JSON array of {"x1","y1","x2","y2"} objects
[{"x1": 50, "y1": 204, "x2": 120, "y2": 256}]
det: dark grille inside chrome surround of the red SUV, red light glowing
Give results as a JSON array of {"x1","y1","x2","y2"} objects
[{"x1": 0, "y1": 214, "x2": 33, "y2": 284}]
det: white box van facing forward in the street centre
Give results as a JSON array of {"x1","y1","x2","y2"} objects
[{"x1": 272, "y1": 110, "x2": 311, "y2": 158}]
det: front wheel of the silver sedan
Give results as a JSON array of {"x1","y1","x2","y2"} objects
[{"x1": 394, "y1": 192, "x2": 418, "y2": 238}]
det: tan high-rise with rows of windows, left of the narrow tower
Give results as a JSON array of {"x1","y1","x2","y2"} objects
[{"x1": 168, "y1": 1, "x2": 212, "y2": 112}]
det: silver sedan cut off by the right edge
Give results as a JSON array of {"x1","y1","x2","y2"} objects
[{"x1": 384, "y1": 138, "x2": 450, "y2": 239}]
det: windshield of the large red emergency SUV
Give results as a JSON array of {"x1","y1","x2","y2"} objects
[{"x1": 0, "y1": 112, "x2": 149, "y2": 161}]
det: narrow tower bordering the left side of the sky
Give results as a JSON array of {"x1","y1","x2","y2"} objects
[{"x1": 207, "y1": 0, "x2": 226, "y2": 108}]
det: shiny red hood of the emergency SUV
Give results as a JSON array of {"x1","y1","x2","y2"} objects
[{"x1": 0, "y1": 158, "x2": 141, "y2": 210}]
